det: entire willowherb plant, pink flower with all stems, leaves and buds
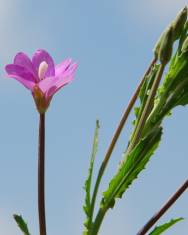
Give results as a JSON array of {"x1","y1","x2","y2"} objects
[{"x1": 1, "y1": 4, "x2": 188, "y2": 235}]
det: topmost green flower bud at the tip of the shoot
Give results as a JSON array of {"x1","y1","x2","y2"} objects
[{"x1": 171, "y1": 6, "x2": 187, "y2": 41}]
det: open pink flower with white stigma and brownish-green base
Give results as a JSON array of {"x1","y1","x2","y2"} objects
[{"x1": 5, "y1": 50, "x2": 77, "y2": 113}]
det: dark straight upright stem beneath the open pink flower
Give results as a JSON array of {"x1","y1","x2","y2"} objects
[{"x1": 38, "y1": 114, "x2": 46, "y2": 235}]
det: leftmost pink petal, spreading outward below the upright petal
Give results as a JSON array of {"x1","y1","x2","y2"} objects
[{"x1": 5, "y1": 64, "x2": 35, "y2": 90}]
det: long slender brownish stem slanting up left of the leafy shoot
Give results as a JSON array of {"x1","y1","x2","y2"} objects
[{"x1": 91, "y1": 58, "x2": 157, "y2": 231}]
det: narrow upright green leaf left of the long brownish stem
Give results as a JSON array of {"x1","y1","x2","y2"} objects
[{"x1": 83, "y1": 120, "x2": 100, "y2": 228}]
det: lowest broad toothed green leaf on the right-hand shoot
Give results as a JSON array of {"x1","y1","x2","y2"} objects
[{"x1": 101, "y1": 127, "x2": 162, "y2": 208}]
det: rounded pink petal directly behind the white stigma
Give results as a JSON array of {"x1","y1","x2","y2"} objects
[{"x1": 32, "y1": 49, "x2": 55, "y2": 77}]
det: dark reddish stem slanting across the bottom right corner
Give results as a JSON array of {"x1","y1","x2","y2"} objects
[{"x1": 137, "y1": 180, "x2": 188, "y2": 235}]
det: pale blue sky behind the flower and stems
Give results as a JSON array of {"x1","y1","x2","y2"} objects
[{"x1": 0, "y1": 0, "x2": 188, "y2": 235}]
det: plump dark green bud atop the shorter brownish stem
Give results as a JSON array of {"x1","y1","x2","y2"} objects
[{"x1": 158, "y1": 27, "x2": 174, "y2": 65}]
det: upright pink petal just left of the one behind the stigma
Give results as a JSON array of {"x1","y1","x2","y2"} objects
[{"x1": 14, "y1": 52, "x2": 37, "y2": 82}]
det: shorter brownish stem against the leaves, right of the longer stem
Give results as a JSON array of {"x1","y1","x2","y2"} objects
[{"x1": 127, "y1": 64, "x2": 165, "y2": 152}]
